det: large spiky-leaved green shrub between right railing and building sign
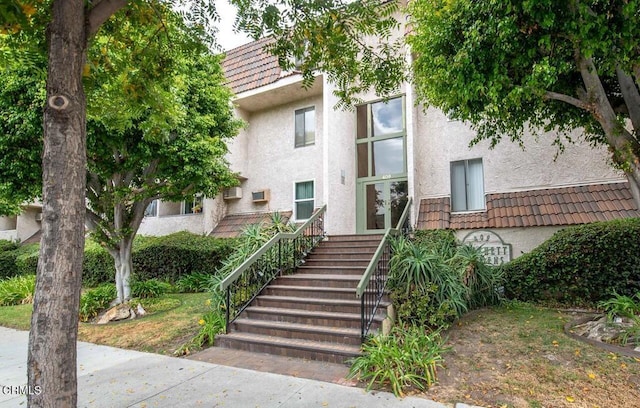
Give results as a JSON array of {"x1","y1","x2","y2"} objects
[{"x1": 389, "y1": 232, "x2": 502, "y2": 328}]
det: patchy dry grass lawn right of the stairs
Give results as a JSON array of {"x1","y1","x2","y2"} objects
[{"x1": 425, "y1": 305, "x2": 640, "y2": 408}]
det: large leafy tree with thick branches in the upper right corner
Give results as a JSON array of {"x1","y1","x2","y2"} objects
[{"x1": 408, "y1": 0, "x2": 640, "y2": 207}]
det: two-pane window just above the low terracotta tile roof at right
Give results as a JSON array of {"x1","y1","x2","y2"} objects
[{"x1": 451, "y1": 159, "x2": 485, "y2": 212}]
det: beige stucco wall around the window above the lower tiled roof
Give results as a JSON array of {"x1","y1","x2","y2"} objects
[{"x1": 414, "y1": 108, "x2": 624, "y2": 198}]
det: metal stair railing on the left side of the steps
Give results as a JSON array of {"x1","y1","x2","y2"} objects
[{"x1": 220, "y1": 205, "x2": 327, "y2": 332}]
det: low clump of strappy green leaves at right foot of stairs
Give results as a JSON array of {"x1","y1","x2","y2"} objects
[{"x1": 348, "y1": 326, "x2": 445, "y2": 397}]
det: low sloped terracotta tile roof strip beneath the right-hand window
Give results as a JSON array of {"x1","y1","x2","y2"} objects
[{"x1": 417, "y1": 183, "x2": 640, "y2": 229}]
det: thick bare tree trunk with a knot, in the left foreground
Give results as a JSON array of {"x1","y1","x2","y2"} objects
[{"x1": 27, "y1": 0, "x2": 87, "y2": 407}]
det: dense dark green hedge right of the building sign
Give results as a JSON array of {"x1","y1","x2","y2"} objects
[{"x1": 503, "y1": 218, "x2": 640, "y2": 306}]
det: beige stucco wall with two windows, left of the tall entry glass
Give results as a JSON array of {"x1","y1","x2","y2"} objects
[{"x1": 226, "y1": 95, "x2": 325, "y2": 220}]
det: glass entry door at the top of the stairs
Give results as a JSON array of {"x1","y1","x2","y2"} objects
[{"x1": 358, "y1": 178, "x2": 408, "y2": 233}]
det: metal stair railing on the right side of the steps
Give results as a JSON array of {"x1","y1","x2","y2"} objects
[{"x1": 356, "y1": 198, "x2": 412, "y2": 342}]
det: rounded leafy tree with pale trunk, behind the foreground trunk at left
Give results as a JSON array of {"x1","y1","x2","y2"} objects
[{"x1": 0, "y1": 5, "x2": 240, "y2": 303}]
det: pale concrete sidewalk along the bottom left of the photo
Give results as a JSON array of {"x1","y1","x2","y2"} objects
[{"x1": 0, "y1": 327, "x2": 478, "y2": 408}]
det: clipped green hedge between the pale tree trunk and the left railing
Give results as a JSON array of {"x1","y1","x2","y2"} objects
[{"x1": 133, "y1": 231, "x2": 235, "y2": 283}]
